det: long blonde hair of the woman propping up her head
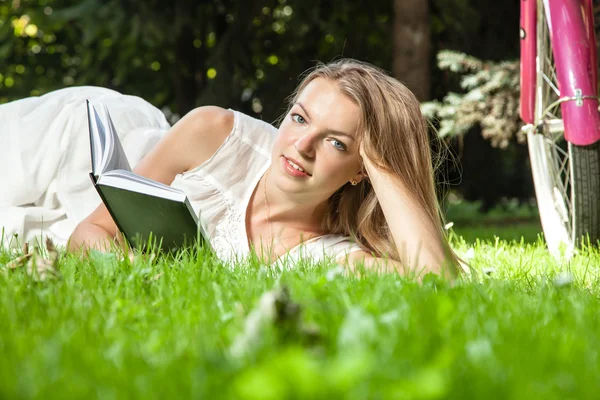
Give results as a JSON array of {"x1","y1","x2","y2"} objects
[{"x1": 288, "y1": 59, "x2": 457, "y2": 272}]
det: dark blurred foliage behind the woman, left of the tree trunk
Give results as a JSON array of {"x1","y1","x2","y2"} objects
[{"x1": 0, "y1": 0, "x2": 391, "y2": 119}]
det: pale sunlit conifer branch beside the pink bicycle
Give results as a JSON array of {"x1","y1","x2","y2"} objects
[{"x1": 421, "y1": 50, "x2": 525, "y2": 148}]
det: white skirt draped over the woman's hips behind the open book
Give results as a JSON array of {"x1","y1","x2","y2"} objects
[{"x1": 0, "y1": 87, "x2": 170, "y2": 246}]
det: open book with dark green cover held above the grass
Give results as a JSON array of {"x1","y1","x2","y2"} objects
[{"x1": 86, "y1": 101, "x2": 205, "y2": 250}]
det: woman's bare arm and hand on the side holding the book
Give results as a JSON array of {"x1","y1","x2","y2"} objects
[{"x1": 68, "y1": 106, "x2": 233, "y2": 251}]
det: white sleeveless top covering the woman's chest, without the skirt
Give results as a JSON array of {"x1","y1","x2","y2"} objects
[{"x1": 171, "y1": 111, "x2": 362, "y2": 266}]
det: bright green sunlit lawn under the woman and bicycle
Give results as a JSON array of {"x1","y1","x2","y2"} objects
[{"x1": 0, "y1": 223, "x2": 600, "y2": 400}]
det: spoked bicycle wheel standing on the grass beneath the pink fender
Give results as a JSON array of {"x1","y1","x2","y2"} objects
[{"x1": 527, "y1": 1, "x2": 600, "y2": 254}]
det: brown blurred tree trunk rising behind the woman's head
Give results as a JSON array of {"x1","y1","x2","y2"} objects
[{"x1": 393, "y1": 0, "x2": 431, "y2": 101}]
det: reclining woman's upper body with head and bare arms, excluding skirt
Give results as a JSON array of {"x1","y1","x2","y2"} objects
[{"x1": 69, "y1": 59, "x2": 459, "y2": 277}]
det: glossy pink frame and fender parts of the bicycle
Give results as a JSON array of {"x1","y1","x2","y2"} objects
[{"x1": 520, "y1": 0, "x2": 600, "y2": 146}]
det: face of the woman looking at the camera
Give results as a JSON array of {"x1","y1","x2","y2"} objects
[{"x1": 269, "y1": 78, "x2": 363, "y2": 202}]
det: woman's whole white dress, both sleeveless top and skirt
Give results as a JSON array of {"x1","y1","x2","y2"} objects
[{"x1": 0, "y1": 87, "x2": 360, "y2": 261}]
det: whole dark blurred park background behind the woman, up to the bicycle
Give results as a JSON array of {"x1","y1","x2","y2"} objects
[{"x1": 0, "y1": 0, "x2": 552, "y2": 240}]
